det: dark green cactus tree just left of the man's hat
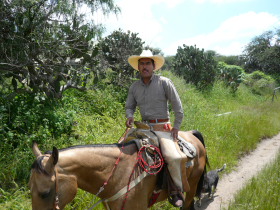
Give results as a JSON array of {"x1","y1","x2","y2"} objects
[{"x1": 96, "y1": 29, "x2": 145, "y2": 87}]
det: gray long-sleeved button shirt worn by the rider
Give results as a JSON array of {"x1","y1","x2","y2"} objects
[{"x1": 125, "y1": 74, "x2": 184, "y2": 129}]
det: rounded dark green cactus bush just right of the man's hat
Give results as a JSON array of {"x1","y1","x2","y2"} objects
[{"x1": 173, "y1": 45, "x2": 217, "y2": 90}]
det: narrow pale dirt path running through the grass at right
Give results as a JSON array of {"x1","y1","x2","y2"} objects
[{"x1": 195, "y1": 133, "x2": 280, "y2": 210}]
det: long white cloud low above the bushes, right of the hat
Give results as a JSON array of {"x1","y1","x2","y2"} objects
[{"x1": 163, "y1": 12, "x2": 280, "y2": 55}]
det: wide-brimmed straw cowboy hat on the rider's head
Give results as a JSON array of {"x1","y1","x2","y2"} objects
[{"x1": 128, "y1": 50, "x2": 164, "y2": 71}]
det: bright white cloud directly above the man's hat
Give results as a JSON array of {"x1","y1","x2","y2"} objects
[{"x1": 99, "y1": 0, "x2": 183, "y2": 46}]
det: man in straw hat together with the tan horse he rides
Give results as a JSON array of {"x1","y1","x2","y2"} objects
[{"x1": 29, "y1": 51, "x2": 207, "y2": 210}]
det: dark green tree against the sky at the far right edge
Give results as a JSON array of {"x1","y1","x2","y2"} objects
[{"x1": 244, "y1": 29, "x2": 280, "y2": 77}]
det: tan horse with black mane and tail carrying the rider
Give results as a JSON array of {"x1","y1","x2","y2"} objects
[{"x1": 29, "y1": 131, "x2": 208, "y2": 210}]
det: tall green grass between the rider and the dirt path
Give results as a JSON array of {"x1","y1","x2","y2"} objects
[{"x1": 164, "y1": 72, "x2": 280, "y2": 170}]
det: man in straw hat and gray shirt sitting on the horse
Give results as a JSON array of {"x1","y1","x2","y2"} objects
[{"x1": 125, "y1": 50, "x2": 185, "y2": 207}]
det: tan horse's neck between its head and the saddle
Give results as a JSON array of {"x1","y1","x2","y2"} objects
[{"x1": 58, "y1": 145, "x2": 136, "y2": 194}]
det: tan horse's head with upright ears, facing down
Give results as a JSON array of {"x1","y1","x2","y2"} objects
[{"x1": 29, "y1": 143, "x2": 59, "y2": 210}]
